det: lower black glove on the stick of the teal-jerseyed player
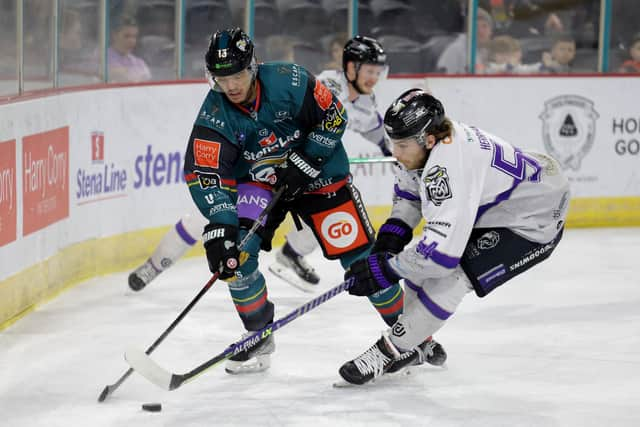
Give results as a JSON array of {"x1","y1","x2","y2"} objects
[{"x1": 202, "y1": 224, "x2": 240, "y2": 280}]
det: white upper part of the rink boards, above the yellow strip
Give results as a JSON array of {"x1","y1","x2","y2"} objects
[{"x1": 0, "y1": 77, "x2": 640, "y2": 280}]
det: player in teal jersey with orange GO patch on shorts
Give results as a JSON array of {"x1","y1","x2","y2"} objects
[{"x1": 185, "y1": 28, "x2": 444, "y2": 373}]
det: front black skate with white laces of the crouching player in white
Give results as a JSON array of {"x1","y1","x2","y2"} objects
[{"x1": 339, "y1": 333, "x2": 418, "y2": 385}]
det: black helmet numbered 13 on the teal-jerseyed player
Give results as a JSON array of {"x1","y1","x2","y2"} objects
[{"x1": 205, "y1": 28, "x2": 254, "y2": 77}]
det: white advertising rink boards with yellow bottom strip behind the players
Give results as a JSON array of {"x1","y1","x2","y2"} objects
[{"x1": 0, "y1": 77, "x2": 640, "y2": 325}]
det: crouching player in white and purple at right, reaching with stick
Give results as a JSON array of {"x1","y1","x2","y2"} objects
[{"x1": 339, "y1": 89, "x2": 570, "y2": 384}]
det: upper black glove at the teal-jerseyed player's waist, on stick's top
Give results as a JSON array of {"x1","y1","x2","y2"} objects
[{"x1": 276, "y1": 150, "x2": 322, "y2": 200}]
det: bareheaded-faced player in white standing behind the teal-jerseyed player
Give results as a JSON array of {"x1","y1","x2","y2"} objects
[{"x1": 269, "y1": 36, "x2": 391, "y2": 291}]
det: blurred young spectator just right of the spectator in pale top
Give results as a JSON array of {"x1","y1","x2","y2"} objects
[{"x1": 485, "y1": 36, "x2": 543, "y2": 74}]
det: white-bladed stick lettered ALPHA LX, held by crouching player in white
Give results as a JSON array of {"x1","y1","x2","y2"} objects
[{"x1": 124, "y1": 279, "x2": 353, "y2": 390}]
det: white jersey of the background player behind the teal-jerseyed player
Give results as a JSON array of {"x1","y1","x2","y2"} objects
[{"x1": 317, "y1": 70, "x2": 384, "y2": 146}]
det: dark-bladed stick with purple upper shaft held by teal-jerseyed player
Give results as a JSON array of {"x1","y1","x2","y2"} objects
[{"x1": 98, "y1": 188, "x2": 284, "y2": 402}]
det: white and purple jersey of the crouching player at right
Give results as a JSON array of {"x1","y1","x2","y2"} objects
[{"x1": 390, "y1": 122, "x2": 569, "y2": 283}]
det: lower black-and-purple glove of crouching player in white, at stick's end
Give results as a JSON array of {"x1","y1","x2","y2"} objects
[{"x1": 344, "y1": 253, "x2": 402, "y2": 297}]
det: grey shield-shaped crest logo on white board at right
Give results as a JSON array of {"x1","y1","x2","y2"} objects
[{"x1": 539, "y1": 95, "x2": 600, "y2": 171}]
